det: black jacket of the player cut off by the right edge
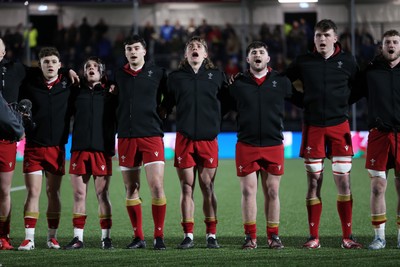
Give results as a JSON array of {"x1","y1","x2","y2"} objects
[{"x1": 359, "y1": 56, "x2": 400, "y2": 131}]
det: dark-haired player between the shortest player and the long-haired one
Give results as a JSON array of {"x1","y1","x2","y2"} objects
[{"x1": 115, "y1": 35, "x2": 167, "y2": 250}]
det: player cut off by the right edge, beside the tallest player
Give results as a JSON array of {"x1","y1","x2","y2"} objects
[{"x1": 357, "y1": 30, "x2": 400, "y2": 250}]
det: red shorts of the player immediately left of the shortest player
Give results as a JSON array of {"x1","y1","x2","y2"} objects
[{"x1": 23, "y1": 144, "x2": 65, "y2": 176}]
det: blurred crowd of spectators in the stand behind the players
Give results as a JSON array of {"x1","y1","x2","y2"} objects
[{"x1": 0, "y1": 17, "x2": 377, "y2": 131}]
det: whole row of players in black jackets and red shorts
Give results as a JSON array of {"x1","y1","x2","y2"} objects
[{"x1": 0, "y1": 19, "x2": 400, "y2": 250}]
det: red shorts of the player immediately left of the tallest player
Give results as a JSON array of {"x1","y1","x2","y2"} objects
[{"x1": 235, "y1": 142, "x2": 285, "y2": 177}]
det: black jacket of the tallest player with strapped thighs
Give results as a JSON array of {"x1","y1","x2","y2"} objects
[{"x1": 286, "y1": 43, "x2": 358, "y2": 127}]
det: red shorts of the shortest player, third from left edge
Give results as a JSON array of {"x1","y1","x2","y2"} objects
[{"x1": 69, "y1": 151, "x2": 112, "y2": 176}]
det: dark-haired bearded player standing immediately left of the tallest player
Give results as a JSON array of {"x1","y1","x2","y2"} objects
[{"x1": 229, "y1": 41, "x2": 292, "y2": 249}]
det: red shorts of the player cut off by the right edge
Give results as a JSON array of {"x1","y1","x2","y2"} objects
[{"x1": 365, "y1": 129, "x2": 400, "y2": 171}]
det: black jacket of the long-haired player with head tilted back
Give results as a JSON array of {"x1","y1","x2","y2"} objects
[{"x1": 163, "y1": 63, "x2": 227, "y2": 140}]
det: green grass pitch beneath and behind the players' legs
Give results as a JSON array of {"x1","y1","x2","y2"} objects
[{"x1": 0, "y1": 159, "x2": 400, "y2": 267}]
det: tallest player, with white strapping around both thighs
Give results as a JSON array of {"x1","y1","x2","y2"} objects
[{"x1": 286, "y1": 19, "x2": 362, "y2": 249}]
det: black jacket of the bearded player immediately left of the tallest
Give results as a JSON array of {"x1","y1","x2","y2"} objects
[{"x1": 229, "y1": 70, "x2": 292, "y2": 147}]
